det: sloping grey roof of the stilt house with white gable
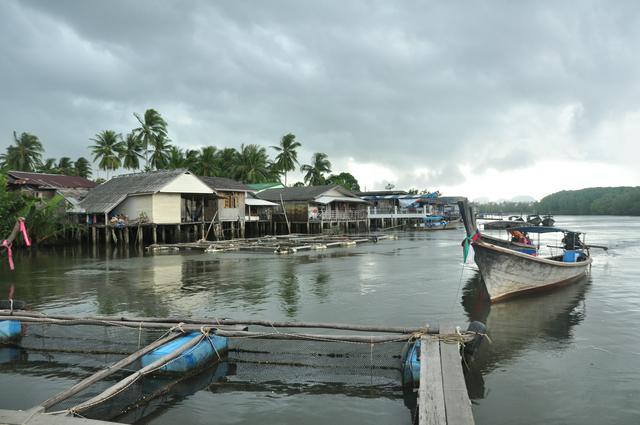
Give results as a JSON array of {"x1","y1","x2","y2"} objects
[{"x1": 79, "y1": 169, "x2": 189, "y2": 213}]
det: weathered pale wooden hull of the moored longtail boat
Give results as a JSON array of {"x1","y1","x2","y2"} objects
[{"x1": 473, "y1": 242, "x2": 591, "y2": 302}]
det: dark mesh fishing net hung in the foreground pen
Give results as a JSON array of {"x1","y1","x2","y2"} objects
[{"x1": 0, "y1": 323, "x2": 420, "y2": 423}]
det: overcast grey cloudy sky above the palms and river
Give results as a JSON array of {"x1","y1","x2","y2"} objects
[{"x1": 0, "y1": 0, "x2": 640, "y2": 200}]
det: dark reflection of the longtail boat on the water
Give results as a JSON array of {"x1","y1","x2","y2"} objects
[{"x1": 462, "y1": 273, "x2": 590, "y2": 398}]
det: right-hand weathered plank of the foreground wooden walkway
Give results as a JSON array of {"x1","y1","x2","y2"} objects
[{"x1": 440, "y1": 326, "x2": 474, "y2": 425}]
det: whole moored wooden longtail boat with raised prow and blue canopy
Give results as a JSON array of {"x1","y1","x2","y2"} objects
[{"x1": 458, "y1": 201, "x2": 592, "y2": 303}]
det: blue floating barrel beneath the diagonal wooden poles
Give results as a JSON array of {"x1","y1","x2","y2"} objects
[{"x1": 141, "y1": 332, "x2": 229, "y2": 373}]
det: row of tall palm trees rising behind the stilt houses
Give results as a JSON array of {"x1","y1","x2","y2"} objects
[{"x1": 0, "y1": 109, "x2": 360, "y2": 191}]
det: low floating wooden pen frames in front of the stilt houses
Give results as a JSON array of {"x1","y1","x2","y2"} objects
[{"x1": 147, "y1": 234, "x2": 395, "y2": 254}]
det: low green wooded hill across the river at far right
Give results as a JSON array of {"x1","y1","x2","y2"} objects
[{"x1": 536, "y1": 186, "x2": 640, "y2": 215}]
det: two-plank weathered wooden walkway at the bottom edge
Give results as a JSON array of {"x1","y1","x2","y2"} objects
[{"x1": 418, "y1": 327, "x2": 474, "y2": 425}]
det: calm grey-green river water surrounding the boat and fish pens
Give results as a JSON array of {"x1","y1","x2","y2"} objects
[{"x1": 0, "y1": 217, "x2": 640, "y2": 425}]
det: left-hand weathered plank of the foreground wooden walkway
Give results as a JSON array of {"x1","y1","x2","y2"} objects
[{"x1": 418, "y1": 336, "x2": 446, "y2": 425}]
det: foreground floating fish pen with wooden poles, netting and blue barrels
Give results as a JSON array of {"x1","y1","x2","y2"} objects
[{"x1": 0, "y1": 310, "x2": 485, "y2": 425}]
